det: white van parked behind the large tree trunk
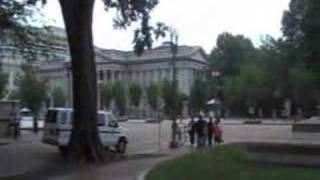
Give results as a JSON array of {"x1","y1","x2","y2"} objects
[{"x1": 42, "y1": 108, "x2": 128, "y2": 154}]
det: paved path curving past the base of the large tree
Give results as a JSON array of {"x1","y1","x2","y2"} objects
[{"x1": 0, "y1": 132, "x2": 189, "y2": 180}]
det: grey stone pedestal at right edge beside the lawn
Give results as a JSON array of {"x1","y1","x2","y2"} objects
[{"x1": 246, "y1": 117, "x2": 320, "y2": 167}]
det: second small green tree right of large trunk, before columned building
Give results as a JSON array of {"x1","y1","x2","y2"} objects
[{"x1": 112, "y1": 81, "x2": 127, "y2": 115}]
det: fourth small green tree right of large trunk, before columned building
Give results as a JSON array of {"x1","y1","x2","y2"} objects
[{"x1": 146, "y1": 83, "x2": 160, "y2": 110}]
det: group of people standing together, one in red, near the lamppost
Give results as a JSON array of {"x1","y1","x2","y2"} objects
[{"x1": 188, "y1": 115, "x2": 223, "y2": 148}]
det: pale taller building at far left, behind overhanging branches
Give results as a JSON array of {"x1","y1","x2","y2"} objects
[{"x1": 0, "y1": 27, "x2": 69, "y2": 98}]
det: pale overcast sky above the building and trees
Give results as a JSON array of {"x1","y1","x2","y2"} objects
[{"x1": 45, "y1": 0, "x2": 290, "y2": 53}]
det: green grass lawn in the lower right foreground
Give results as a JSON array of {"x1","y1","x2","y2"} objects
[{"x1": 146, "y1": 145, "x2": 320, "y2": 180}]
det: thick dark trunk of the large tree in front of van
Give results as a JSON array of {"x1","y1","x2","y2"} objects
[{"x1": 59, "y1": 0, "x2": 104, "y2": 161}]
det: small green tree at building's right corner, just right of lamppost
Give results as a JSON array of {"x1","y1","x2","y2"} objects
[{"x1": 190, "y1": 79, "x2": 209, "y2": 114}]
